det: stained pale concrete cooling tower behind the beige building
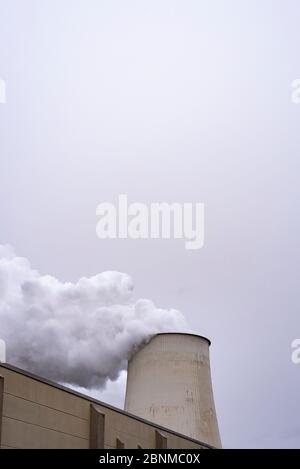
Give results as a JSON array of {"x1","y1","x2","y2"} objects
[{"x1": 125, "y1": 333, "x2": 221, "y2": 448}]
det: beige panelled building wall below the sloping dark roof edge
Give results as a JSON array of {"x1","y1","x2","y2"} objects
[{"x1": 0, "y1": 364, "x2": 211, "y2": 449}]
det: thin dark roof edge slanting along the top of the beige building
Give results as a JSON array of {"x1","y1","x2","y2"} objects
[{"x1": 0, "y1": 360, "x2": 215, "y2": 449}]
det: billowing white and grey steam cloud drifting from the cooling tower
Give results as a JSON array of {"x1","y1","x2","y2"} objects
[{"x1": 0, "y1": 245, "x2": 186, "y2": 387}]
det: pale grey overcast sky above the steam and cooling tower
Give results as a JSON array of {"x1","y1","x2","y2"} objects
[{"x1": 0, "y1": 0, "x2": 300, "y2": 448}]
